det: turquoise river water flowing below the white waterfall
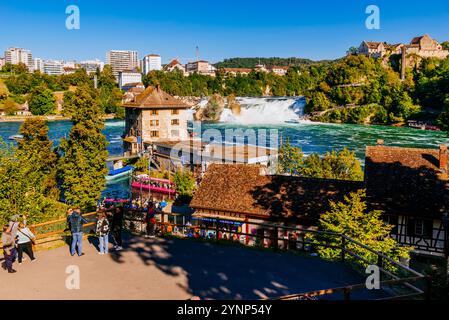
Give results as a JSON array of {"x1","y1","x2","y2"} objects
[{"x1": 0, "y1": 120, "x2": 449, "y2": 197}]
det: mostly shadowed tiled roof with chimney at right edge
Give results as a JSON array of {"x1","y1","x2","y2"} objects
[{"x1": 365, "y1": 146, "x2": 449, "y2": 217}]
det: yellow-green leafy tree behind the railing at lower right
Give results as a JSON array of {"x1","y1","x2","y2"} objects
[{"x1": 313, "y1": 190, "x2": 410, "y2": 270}]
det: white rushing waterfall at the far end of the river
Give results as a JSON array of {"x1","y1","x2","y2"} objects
[{"x1": 220, "y1": 97, "x2": 305, "y2": 124}]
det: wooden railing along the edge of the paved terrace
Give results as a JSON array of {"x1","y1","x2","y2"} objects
[{"x1": 2, "y1": 210, "x2": 431, "y2": 300}]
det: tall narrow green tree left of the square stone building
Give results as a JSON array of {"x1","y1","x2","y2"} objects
[{"x1": 58, "y1": 85, "x2": 108, "y2": 210}]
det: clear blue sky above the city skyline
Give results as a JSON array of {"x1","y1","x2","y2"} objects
[{"x1": 0, "y1": 0, "x2": 449, "y2": 62}]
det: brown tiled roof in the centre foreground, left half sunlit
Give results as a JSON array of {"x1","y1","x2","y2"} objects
[{"x1": 190, "y1": 164, "x2": 363, "y2": 224}]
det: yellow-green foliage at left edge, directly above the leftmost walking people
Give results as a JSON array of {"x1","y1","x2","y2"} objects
[{"x1": 0, "y1": 120, "x2": 66, "y2": 228}]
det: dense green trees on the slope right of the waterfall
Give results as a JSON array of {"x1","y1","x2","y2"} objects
[{"x1": 304, "y1": 55, "x2": 429, "y2": 123}]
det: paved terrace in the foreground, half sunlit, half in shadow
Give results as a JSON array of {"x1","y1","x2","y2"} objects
[{"x1": 0, "y1": 232, "x2": 382, "y2": 299}]
